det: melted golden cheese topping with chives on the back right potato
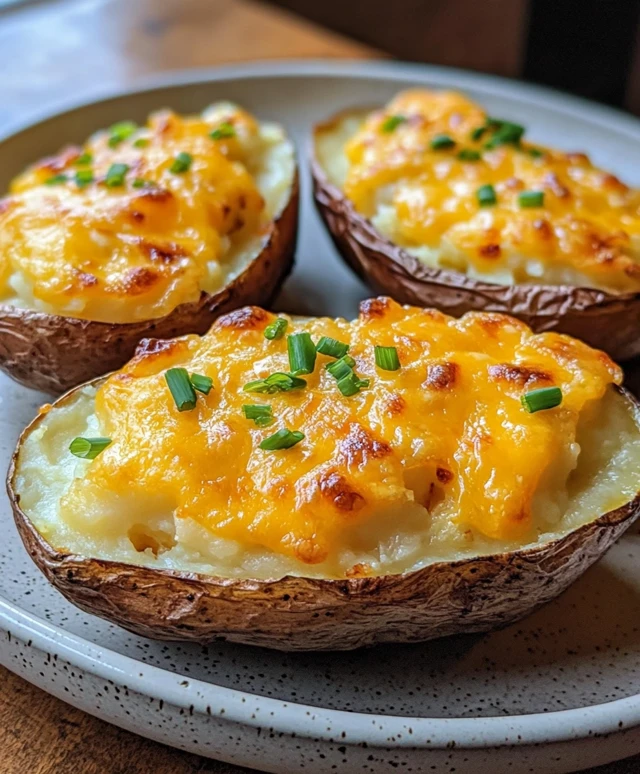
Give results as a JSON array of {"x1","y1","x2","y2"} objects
[{"x1": 344, "y1": 90, "x2": 640, "y2": 291}]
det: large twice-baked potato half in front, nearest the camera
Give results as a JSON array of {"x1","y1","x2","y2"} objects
[{"x1": 8, "y1": 298, "x2": 640, "y2": 650}]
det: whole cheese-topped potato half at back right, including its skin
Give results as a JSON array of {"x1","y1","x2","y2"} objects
[{"x1": 312, "y1": 89, "x2": 640, "y2": 360}]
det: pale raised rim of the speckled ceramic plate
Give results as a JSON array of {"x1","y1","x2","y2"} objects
[{"x1": 0, "y1": 59, "x2": 640, "y2": 749}]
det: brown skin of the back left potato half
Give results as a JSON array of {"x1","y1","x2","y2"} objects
[{"x1": 0, "y1": 171, "x2": 300, "y2": 395}]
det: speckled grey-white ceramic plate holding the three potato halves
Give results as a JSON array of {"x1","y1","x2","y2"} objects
[{"x1": 0, "y1": 62, "x2": 640, "y2": 774}]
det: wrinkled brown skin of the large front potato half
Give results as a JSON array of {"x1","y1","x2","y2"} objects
[{"x1": 7, "y1": 380, "x2": 640, "y2": 651}]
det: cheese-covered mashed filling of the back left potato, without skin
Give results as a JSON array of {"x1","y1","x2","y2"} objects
[{"x1": 0, "y1": 103, "x2": 295, "y2": 323}]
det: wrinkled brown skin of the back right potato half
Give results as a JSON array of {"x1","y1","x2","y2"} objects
[{"x1": 311, "y1": 111, "x2": 640, "y2": 361}]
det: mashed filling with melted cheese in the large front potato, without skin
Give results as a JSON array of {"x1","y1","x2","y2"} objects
[{"x1": 16, "y1": 298, "x2": 640, "y2": 578}]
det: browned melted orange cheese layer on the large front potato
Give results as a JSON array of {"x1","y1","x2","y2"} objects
[{"x1": 61, "y1": 298, "x2": 622, "y2": 564}]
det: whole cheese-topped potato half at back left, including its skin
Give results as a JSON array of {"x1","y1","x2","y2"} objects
[{"x1": 0, "y1": 103, "x2": 298, "y2": 394}]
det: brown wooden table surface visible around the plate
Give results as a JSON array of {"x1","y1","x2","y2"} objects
[{"x1": 0, "y1": 0, "x2": 640, "y2": 774}]
